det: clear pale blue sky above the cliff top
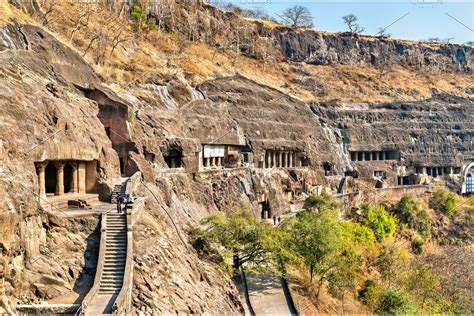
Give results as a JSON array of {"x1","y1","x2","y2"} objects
[{"x1": 224, "y1": 0, "x2": 474, "y2": 43}]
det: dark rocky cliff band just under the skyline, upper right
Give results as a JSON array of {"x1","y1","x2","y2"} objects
[{"x1": 266, "y1": 26, "x2": 474, "y2": 72}]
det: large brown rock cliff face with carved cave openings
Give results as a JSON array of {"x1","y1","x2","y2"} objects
[{"x1": 0, "y1": 14, "x2": 474, "y2": 313}]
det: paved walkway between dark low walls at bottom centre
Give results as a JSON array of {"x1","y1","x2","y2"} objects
[{"x1": 247, "y1": 273, "x2": 291, "y2": 315}]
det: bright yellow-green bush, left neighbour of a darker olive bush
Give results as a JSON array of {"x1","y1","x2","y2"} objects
[{"x1": 361, "y1": 204, "x2": 397, "y2": 241}]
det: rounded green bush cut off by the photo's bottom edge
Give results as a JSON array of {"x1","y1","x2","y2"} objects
[{"x1": 375, "y1": 289, "x2": 416, "y2": 314}]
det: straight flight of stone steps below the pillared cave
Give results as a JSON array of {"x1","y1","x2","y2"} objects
[{"x1": 99, "y1": 213, "x2": 127, "y2": 295}]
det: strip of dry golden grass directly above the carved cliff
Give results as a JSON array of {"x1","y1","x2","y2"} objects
[{"x1": 1, "y1": 2, "x2": 474, "y2": 103}]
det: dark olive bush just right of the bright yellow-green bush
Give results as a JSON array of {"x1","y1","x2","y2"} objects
[{"x1": 395, "y1": 195, "x2": 431, "y2": 237}]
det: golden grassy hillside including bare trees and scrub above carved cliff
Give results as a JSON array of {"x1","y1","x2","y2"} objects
[{"x1": 0, "y1": 1, "x2": 472, "y2": 103}]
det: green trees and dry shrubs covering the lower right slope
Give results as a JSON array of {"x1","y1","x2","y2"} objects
[{"x1": 193, "y1": 189, "x2": 473, "y2": 314}]
